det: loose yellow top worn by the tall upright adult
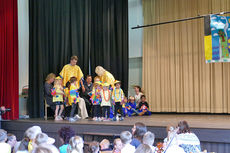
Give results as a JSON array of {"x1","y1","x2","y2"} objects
[{"x1": 60, "y1": 64, "x2": 83, "y2": 88}]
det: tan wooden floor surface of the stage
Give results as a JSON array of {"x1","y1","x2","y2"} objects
[{"x1": 13, "y1": 114, "x2": 230, "y2": 129}]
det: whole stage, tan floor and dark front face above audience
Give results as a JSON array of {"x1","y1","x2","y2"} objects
[{"x1": 2, "y1": 114, "x2": 230, "y2": 153}]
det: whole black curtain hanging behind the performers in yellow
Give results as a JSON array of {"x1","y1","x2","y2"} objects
[{"x1": 28, "y1": 0, "x2": 128, "y2": 117}]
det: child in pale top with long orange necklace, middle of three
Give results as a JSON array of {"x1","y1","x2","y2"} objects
[{"x1": 101, "y1": 83, "x2": 111, "y2": 121}]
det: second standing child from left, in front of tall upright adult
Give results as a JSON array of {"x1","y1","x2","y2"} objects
[{"x1": 68, "y1": 77, "x2": 80, "y2": 122}]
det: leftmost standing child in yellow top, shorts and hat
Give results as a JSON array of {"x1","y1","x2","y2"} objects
[{"x1": 52, "y1": 76, "x2": 64, "y2": 120}]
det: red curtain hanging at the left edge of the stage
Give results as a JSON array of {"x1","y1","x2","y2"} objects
[{"x1": 0, "y1": 0, "x2": 19, "y2": 119}]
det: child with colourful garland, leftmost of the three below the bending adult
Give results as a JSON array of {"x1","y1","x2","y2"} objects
[{"x1": 90, "y1": 81, "x2": 101, "y2": 121}]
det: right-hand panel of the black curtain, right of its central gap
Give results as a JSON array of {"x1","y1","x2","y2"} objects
[{"x1": 90, "y1": 0, "x2": 129, "y2": 95}]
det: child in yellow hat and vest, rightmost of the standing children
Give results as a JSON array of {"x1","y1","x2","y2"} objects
[{"x1": 112, "y1": 81, "x2": 124, "y2": 121}]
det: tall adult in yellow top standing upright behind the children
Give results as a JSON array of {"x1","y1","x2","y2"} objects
[{"x1": 60, "y1": 56, "x2": 85, "y2": 92}]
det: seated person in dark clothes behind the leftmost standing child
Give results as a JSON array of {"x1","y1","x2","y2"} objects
[{"x1": 44, "y1": 73, "x2": 56, "y2": 113}]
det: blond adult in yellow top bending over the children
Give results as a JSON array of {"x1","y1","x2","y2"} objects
[{"x1": 95, "y1": 66, "x2": 115, "y2": 89}]
